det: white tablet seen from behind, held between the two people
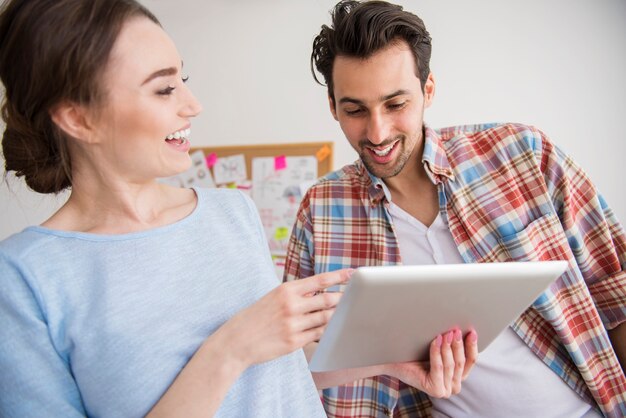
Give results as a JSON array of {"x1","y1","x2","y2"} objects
[{"x1": 309, "y1": 261, "x2": 567, "y2": 372}]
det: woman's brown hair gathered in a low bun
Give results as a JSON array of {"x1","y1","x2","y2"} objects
[{"x1": 0, "y1": 0, "x2": 159, "y2": 193}]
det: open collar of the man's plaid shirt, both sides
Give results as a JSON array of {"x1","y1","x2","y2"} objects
[{"x1": 356, "y1": 125, "x2": 454, "y2": 205}]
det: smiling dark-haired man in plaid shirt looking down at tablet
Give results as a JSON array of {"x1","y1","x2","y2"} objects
[{"x1": 285, "y1": 1, "x2": 626, "y2": 417}]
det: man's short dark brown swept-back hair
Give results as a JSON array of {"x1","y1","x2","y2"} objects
[{"x1": 311, "y1": 0, "x2": 431, "y2": 101}]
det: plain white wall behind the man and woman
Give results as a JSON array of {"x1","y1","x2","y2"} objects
[{"x1": 0, "y1": 0, "x2": 626, "y2": 239}]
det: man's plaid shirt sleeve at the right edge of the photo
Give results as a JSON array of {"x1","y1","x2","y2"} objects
[{"x1": 540, "y1": 128, "x2": 626, "y2": 329}]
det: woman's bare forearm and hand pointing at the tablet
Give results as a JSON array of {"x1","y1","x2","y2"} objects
[{"x1": 148, "y1": 270, "x2": 350, "y2": 418}]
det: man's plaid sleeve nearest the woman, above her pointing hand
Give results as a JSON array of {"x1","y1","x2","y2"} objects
[{"x1": 283, "y1": 190, "x2": 315, "y2": 282}]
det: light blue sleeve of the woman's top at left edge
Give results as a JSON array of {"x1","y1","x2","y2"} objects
[{"x1": 0, "y1": 253, "x2": 86, "y2": 418}]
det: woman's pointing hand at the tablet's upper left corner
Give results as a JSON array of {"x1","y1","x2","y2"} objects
[{"x1": 214, "y1": 269, "x2": 352, "y2": 367}]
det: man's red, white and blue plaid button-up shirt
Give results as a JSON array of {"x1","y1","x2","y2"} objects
[{"x1": 285, "y1": 124, "x2": 626, "y2": 417}]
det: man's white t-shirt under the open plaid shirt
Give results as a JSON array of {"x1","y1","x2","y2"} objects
[{"x1": 389, "y1": 203, "x2": 602, "y2": 418}]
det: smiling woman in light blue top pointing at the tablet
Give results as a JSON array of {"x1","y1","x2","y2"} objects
[{"x1": 0, "y1": 0, "x2": 475, "y2": 417}]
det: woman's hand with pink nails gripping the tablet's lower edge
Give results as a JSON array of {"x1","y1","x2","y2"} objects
[{"x1": 384, "y1": 329, "x2": 478, "y2": 398}]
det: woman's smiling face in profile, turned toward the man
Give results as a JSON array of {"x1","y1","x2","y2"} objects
[{"x1": 88, "y1": 17, "x2": 201, "y2": 183}]
